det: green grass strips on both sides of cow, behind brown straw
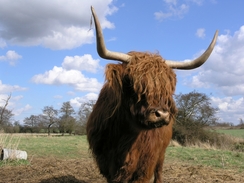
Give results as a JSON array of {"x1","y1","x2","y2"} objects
[{"x1": 0, "y1": 135, "x2": 244, "y2": 172}]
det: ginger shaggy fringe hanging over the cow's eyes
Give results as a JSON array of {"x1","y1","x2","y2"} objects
[{"x1": 125, "y1": 52, "x2": 176, "y2": 113}]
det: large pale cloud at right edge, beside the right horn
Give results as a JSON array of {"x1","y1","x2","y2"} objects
[{"x1": 180, "y1": 25, "x2": 244, "y2": 124}]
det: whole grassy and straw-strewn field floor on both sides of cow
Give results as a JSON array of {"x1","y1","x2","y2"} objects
[{"x1": 0, "y1": 134, "x2": 244, "y2": 183}]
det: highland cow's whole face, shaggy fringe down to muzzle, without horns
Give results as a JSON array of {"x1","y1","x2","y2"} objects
[{"x1": 122, "y1": 52, "x2": 176, "y2": 128}]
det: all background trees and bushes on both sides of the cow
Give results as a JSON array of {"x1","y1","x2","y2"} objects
[{"x1": 0, "y1": 91, "x2": 244, "y2": 137}]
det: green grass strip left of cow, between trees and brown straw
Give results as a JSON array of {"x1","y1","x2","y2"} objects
[{"x1": 0, "y1": 135, "x2": 89, "y2": 159}]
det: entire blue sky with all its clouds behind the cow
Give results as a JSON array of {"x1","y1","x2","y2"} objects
[{"x1": 0, "y1": 0, "x2": 244, "y2": 124}]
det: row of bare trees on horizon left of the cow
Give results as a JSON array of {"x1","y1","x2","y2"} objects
[{"x1": 0, "y1": 95, "x2": 95, "y2": 135}]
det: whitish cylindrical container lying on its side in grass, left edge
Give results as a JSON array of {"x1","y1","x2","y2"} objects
[{"x1": 1, "y1": 149, "x2": 27, "y2": 160}]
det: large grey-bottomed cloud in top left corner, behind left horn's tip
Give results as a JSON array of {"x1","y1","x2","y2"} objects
[{"x1": 0, "y1": 0, "x2": 117, "y2": 50}]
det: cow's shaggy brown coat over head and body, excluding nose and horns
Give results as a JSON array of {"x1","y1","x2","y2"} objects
[{"x1": 87, "y1": 52, "x2": 176, "y2": 183}]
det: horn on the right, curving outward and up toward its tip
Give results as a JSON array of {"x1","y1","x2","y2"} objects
[{"x1": 165, "y1": 30, "x2": 218, "y2": 70}]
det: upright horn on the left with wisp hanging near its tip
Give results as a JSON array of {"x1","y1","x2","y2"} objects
[{"x1": 91, "y1": 6, "x2": 131, "y2": 63}]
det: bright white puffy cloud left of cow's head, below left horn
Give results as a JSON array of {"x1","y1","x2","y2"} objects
[{"x1": 32, "y1": 54, "x2": 102, "y2": 92}]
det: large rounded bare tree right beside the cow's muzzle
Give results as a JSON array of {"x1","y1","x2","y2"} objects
[{"x1": 173, "y1": 91, "x2": 217, "y2": 143}]
